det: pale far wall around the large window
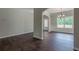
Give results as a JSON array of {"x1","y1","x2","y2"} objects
[{"x1": 50, "y1": 11, "x2": 74, "y2": 33}]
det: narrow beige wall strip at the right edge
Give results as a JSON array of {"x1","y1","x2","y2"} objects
[{"x1": 74, "y1": 8, "x2": 79, "y2": 50}]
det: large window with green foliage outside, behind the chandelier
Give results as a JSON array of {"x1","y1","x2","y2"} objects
[{"x1": 57, "y1": 16, "x2": 73, "y2": 28}]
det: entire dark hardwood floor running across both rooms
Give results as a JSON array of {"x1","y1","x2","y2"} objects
[{"x1": 0, "y1": 32, "x2": 73, "y2": 51}]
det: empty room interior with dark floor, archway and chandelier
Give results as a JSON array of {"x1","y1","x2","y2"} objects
[{"x1": 0, "y1": 8, "x2": 79, "y2": 51}]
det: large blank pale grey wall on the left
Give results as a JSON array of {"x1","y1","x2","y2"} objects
[{"x1": 0, "y1": 8, "x2": 33, "y2": 38}]
